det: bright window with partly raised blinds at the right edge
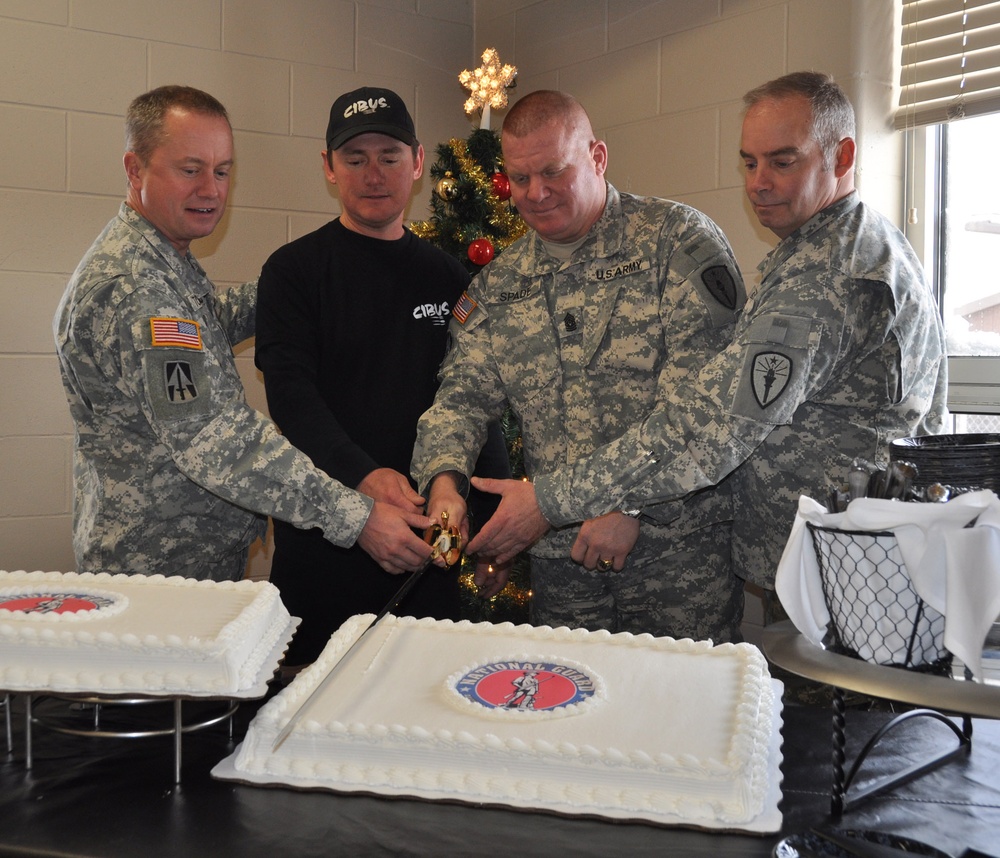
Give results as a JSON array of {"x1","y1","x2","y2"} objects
[{"x1": 896, "y1": 0, "x2": 1000, "y2": 422}]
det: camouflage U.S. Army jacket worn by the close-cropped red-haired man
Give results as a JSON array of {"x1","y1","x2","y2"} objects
[{"x1": 413, "y1": 185, "x2": 746, "y2": 557}]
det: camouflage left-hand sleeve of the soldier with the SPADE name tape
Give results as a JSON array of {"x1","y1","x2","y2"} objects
[{"x1": 410, "y1": 275, "x2": 506, "y2": 495}]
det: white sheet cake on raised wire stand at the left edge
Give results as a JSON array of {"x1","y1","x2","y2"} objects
[{"x1": 0, "y1": 571, "x2": 292, "y2": 696}]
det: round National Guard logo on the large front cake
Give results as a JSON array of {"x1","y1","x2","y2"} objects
[{"x1": 454, "y1": 658, "x2": 597, "y2": 714}]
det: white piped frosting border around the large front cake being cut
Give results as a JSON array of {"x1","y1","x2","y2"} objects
[{"x1": 242, "y1": 614, "x2": 780, "y2": 825}]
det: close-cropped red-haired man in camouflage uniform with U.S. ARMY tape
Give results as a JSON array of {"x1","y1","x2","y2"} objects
[{"x1": 413, "y1": 91, "x2": 745, "y2": 640}]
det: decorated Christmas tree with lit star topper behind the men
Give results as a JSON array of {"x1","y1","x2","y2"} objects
[{"x1": 410, "y1": 48, "x2": 531, "y2": 623}]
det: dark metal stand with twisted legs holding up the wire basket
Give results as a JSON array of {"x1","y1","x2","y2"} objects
[{"x1": 761, "y1": 620, "x2": 1000, "y2": 817}]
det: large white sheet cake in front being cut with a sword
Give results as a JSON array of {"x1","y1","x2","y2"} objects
[{"x1": 227, "y1": 615, "x2": 780, "y2": 830}]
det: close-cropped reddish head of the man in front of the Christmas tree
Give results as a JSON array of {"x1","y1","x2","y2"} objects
[{"x1": 500, "y1": 90, "x2": 608, "y2": 244}]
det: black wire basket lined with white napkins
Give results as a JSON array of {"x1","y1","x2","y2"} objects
[{"x1": 806, "y1": 524, "x2": 952, "y2": 675}]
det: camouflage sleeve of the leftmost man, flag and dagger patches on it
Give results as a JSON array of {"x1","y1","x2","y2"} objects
[{"x1": 114, "y1": 287, "x2": 372, "y2": 546}]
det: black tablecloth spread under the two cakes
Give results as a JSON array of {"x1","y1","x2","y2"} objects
[{"x1": 0, "y1": 697, "x2": 1000, "y2": 858}]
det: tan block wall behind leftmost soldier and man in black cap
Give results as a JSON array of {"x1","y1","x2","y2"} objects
[{"x1": 0, "y1": 0, "x2": 473, "y2": 574}]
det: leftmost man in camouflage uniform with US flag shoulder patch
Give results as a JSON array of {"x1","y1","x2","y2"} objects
[{"x1": 53, "y1": 87, "x2": 431, "y2": 580}]
